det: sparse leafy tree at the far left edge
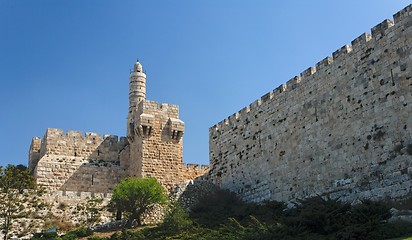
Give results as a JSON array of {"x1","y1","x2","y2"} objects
[{"x1": 0, "y1": 165, "x2": 41, "y2": 240}]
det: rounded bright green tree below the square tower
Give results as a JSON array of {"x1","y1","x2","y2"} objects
[{"x1": 111, "y1": 178, "x2": 167, "y2": 226}]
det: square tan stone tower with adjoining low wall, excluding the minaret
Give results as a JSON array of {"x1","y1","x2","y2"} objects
[{"x1": 130, "y1": 100, "x2": 208, "y2": 190}]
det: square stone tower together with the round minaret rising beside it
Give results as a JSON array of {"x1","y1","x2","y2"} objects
[{"x1": 127, "y1": 59, "x2": 185, "y2": 188}]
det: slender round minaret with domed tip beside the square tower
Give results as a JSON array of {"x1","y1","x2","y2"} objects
[{"x1": 127, "y1": 60, "x2": 146, "y2": 139}]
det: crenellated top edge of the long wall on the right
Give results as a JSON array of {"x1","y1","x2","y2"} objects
[{"x1": 210, "y1": 4, "x2": 412, "y2": 134}]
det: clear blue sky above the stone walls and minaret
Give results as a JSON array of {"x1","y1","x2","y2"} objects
[{"x1": 0, "y1": 0, "x2": 410, "y2": 168}]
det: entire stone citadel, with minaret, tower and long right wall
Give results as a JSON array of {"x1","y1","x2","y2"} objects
[{"x1": 29, "y1": 5, "x2": 412, "y2": 202}]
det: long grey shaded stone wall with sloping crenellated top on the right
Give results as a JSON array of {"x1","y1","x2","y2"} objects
[{"x1": 209, "y1": 5, "x2": 412, "y2": 202}]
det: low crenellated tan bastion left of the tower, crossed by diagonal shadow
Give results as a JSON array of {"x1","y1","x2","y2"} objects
[{"x1": 29, "y1": 128, "x2": 129, "y2": 193}]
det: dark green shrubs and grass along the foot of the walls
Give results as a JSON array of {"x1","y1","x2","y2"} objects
[{"x1": 36, "y1": 190, "x2": 412, "y2": 240}]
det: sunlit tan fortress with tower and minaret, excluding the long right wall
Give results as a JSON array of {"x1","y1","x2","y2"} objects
[{"x1": 29, "y1": 61, "x2": 208, "y2": 193}]
